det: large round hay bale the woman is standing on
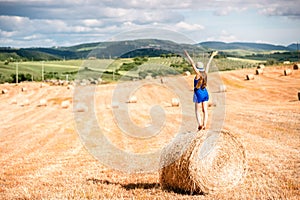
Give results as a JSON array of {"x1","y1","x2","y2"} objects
[{"x1": 160, "y1": 130, "x2": 247, "y2": 194}]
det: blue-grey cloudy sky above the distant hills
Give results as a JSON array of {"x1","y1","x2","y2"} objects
[{"x1": 0, "y1": 0, "x2": 300, "y2": 47}]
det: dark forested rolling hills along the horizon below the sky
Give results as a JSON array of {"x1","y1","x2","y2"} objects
[{"x1": 0, "y1": 39, "x2": 297, "y2": 61}]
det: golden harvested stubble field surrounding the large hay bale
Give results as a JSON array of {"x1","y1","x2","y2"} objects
[{"x1": 0, "y1": 66, "x2": 300, "y2": 199}]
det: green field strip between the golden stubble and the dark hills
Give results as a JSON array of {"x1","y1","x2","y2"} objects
[{"x1": 0, "y1": 57, "x2": 262, "y2": 83}]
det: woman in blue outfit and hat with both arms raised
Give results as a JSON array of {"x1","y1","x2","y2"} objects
[{"x1": 184, "y1": 50, "x2": 218, "y2": 131}]
